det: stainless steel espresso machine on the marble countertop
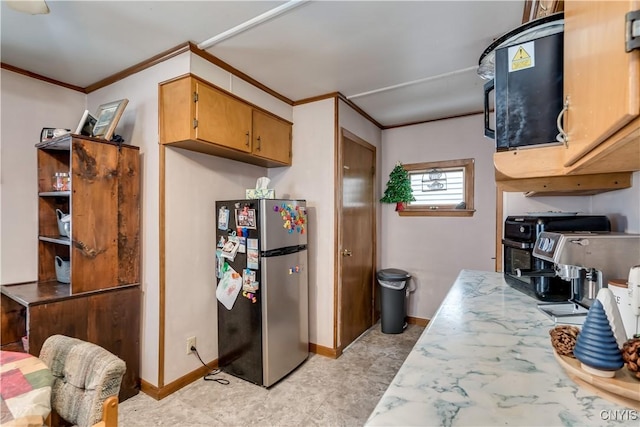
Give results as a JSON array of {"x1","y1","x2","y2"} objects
[{"x1": 533, "y1": 232, "x2": 640, "y2": 323}]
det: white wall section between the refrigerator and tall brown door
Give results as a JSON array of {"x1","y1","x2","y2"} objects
[{"x1": 268, "y1": 99, "x2": 335, "y2": 348}]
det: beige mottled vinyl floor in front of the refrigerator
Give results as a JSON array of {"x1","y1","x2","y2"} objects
[{"x1": 118, "y1": 323, "x2": 424, "y2": 427}]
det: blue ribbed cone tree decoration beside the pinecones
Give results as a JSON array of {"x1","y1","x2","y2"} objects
[{"x1": 573, "y1": 299, "x2": 624, "y2": 377}]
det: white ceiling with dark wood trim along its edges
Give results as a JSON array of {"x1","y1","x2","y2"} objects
[{"x1": 0, "y1": 0, "x2": 525, "y2": 127}]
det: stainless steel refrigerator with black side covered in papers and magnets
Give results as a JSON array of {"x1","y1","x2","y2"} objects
[{"x1": 216, "y1": 199, "x2": 309, "y2": 387}]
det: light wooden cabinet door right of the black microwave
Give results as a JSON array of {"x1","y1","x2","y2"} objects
[{"x1": 564, "y1": 0, "x2": 640, "y2": 166}]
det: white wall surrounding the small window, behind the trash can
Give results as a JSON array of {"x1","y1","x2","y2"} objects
[{"x1": 379, "y1": 115, "x2": 496, "y2": 318}]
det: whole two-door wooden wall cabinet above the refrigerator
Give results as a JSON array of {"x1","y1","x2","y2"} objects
[{"x1": 159, "y1": 75, "x2": 292, "y2": 167}]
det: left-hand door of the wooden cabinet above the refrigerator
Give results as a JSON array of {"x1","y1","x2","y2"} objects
[{"x1": 196, "y1": 82, "x2": 251, "y2": 153}]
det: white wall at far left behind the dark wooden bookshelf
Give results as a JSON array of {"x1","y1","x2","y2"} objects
[{"x1": 0, "y1": 69, "x2": 85, "y2": 284}]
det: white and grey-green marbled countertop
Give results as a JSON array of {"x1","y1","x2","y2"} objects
[{"x1": 366, "y1": 270, "x2": 640, "y2": 426}]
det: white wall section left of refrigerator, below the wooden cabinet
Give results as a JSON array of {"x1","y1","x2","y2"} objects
[{"x1": 164, "y1": 148, "x2": 267, "y2": 384}]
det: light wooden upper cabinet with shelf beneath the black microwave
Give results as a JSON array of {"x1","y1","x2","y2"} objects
[{"x1": 494, "y1": 0, "x2": 640, "y2": 179}]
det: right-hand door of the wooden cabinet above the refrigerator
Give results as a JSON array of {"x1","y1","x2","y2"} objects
[{"x1": 253, "y1": 110, "x2": 291, "y2": 165}]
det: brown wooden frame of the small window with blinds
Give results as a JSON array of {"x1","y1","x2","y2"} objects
[{"x1": 398, "y1": 159, "x2": 475, "y2": 216}]
